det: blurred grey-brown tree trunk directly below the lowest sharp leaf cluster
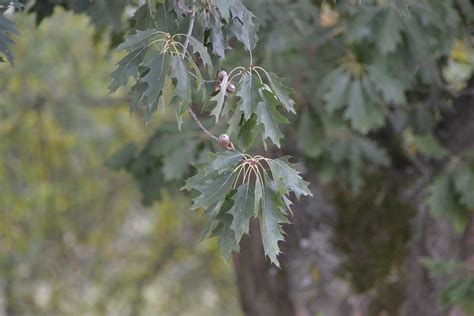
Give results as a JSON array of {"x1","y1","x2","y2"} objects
[{"x1": 234, "y1": 178, "x2": 350, "y2": 316}]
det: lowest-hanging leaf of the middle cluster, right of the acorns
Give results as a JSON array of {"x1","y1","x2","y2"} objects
[{"x1": 257, "y1": 89, "x2": 288, "y2": 147}]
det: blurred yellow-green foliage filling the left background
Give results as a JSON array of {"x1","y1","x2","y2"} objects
[{"x1": 0, "y1": 9, "x2": 240, "y2": 316}]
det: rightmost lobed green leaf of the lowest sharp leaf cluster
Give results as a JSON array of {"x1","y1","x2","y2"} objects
[{"x1": 268, "y1": 157, "x2": 313, "y2": 199}]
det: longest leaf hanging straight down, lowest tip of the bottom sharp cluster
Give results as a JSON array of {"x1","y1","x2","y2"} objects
[{"x1": 260, "y1": 188, "x2": 288, "y2": 267}]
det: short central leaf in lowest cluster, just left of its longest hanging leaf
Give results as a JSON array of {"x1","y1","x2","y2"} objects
[{"x1": 228, "y1": 183, "x2": 257, "y2": 243}]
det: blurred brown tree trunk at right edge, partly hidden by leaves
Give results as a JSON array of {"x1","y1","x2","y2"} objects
[{"x1": 403, "y1": 89, "x2": 474, "y2": 316}]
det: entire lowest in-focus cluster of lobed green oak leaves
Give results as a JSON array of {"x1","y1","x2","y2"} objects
[{"x1": 183, "y1": 150, "x2": 312, "y2": 266}]
